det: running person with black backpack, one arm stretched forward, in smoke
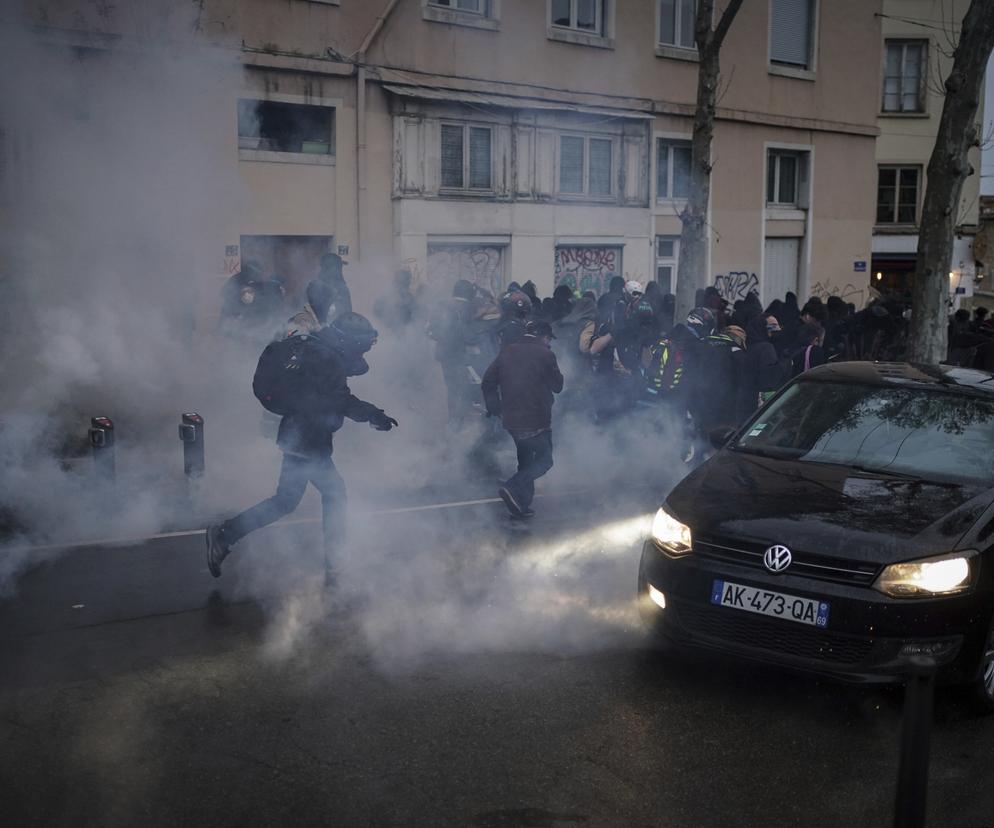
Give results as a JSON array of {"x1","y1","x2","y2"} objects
[{"x1": 207, "y1": 312, "x2": 397, "y2": 581}]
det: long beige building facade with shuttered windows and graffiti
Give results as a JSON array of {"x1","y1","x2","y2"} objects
[{"x1": 3, "y1": 0, "x2": 880, "y2": 310}]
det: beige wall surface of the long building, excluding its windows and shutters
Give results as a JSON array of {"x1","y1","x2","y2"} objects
[{"x1": 9, "y1": 0, "x2": 882, "y2": 308}]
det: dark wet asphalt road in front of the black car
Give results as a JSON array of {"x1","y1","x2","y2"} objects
[{"x1": 0, "y1": 486, "x2": 994, "y2": 828}]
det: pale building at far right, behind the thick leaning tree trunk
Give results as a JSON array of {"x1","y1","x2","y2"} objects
[{"x1": 871, "y1": 0, "x2": 984, "y2": 307}]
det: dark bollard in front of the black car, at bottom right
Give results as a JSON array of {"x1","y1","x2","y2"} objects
[{"x1": 894, "y1": 656, "x2": 935, "y2": 828}]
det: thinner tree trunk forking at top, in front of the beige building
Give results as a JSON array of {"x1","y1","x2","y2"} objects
[{"x1": 675, "y1": 0, "x2": 742, "y2": 321}]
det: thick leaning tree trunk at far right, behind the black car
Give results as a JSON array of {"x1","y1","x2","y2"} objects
[{"x1": 908, "y1": 0, "x2": 994, "y2": 363}]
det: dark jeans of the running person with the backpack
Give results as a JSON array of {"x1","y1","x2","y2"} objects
[{"x1": 221, "y1": 454, "x2": 345, "y2": 561}]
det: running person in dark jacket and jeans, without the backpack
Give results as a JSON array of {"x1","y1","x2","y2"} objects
[{"x1": 207, "y1": 313, "x2": 397, "y2": 578}]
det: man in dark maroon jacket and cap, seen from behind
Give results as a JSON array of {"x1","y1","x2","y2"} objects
[{"x1": 482, "y1": 320, "x2": 563, "y2": 518}]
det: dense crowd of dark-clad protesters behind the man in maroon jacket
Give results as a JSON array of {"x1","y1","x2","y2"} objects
[{"x1": 427, "y1": 277, "x2": 907, "y2": 446}]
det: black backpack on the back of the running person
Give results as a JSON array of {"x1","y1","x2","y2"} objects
[{"x1": 252, "y1": 334, "x2": 323, "y2": 416}]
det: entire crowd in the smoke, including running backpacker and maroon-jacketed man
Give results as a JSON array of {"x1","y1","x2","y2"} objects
[{"x1": 207, "y1": 254, "x2": 928, "y2": 580}]
